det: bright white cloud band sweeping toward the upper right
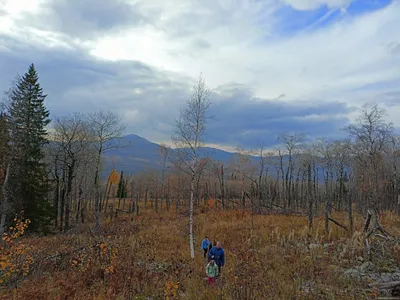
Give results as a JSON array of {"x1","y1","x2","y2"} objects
[{"x1": 80, "y1": 1, "x2": 400, "y2": 100}]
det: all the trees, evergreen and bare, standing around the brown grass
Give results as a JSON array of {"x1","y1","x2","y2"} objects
[{"x1": 0, "y1": 65, "x2": 400, "y2": 299}]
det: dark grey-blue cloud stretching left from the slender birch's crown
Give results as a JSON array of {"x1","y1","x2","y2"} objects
[{"x1": 0, "y1": 39, "x2": 193, "y2": 140}]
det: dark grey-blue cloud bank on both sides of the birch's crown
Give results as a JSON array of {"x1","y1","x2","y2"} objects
[{"x1": 1, "y1": 37, "x2": 348, "y2": 148}]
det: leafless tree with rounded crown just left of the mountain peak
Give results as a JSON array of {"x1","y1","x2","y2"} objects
[{"x1": 89, "y1": 110, "x2": 126, "y2": 232}]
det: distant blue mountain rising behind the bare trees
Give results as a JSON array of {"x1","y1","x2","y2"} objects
[{"x1": 103, "y1": 134, "x2": 238, "y2": 176}]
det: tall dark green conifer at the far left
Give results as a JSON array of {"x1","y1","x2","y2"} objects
[{"x1": 9, "y1": 64, "x2": 51, "y2": 229}]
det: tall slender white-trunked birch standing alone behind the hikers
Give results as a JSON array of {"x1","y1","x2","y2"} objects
[{"x1": 172, "y1": 76, "x2": 211, "y2": 258}]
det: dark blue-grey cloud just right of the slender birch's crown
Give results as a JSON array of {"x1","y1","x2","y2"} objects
[{"x1": 207, "y1": 88, "x2": 355, "y2": 148}]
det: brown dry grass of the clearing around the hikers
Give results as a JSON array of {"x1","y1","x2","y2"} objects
[{"x1": 0, "y1": 209, "x2": 400, "y2": 300}]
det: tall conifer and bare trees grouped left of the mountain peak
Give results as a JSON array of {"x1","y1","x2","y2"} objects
[{"x1": 0, "y1": 64, "x2": 125, "y2": 234}]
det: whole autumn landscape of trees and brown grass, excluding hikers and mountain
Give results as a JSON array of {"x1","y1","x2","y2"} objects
[{"x1": 0, "y1": 64, "x2": 400, "y2": 299}]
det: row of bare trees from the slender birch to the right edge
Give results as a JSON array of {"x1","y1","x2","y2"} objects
[{"x1": 124, "y1": 78, "x2": 400, "y2": 244}]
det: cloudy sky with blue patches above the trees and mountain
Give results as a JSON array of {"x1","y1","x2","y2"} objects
[{"x1": 0, "y1": 0, "x2": 400, "y2": 150}]
